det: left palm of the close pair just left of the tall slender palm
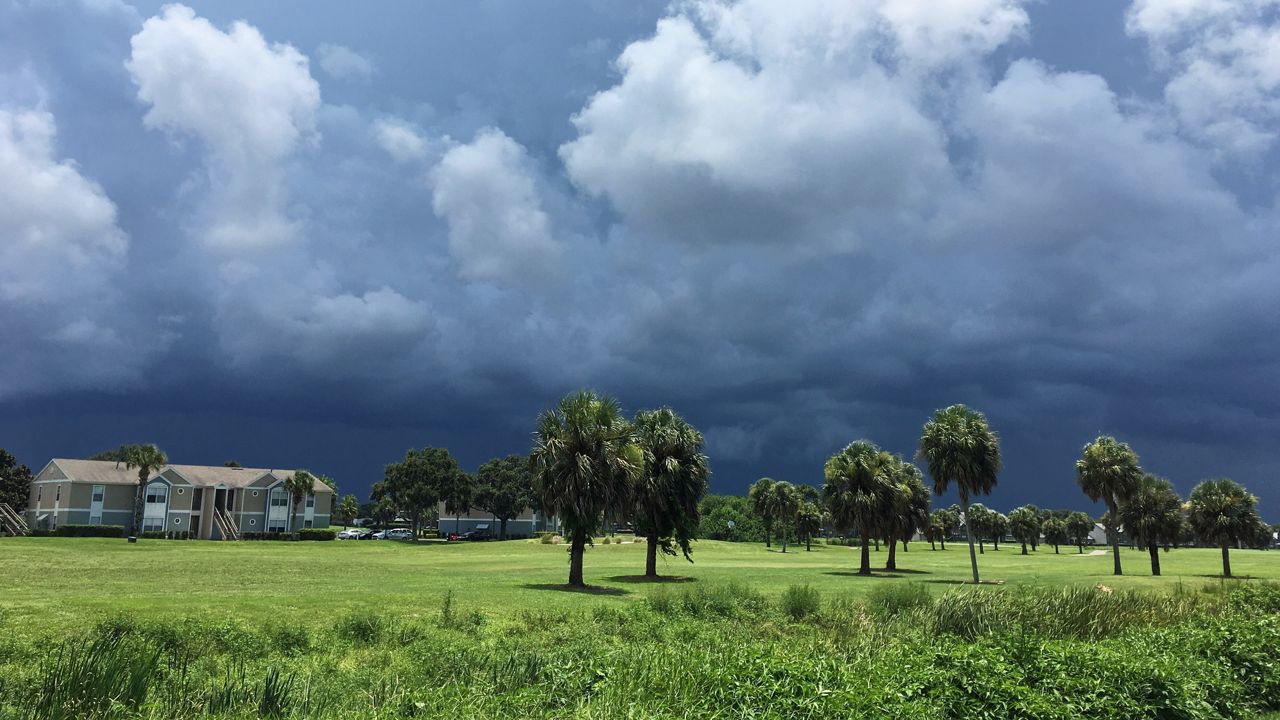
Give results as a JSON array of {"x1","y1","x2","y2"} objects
[{"x1": 822, "y1": 439, "x2": 893, "y2": 575}]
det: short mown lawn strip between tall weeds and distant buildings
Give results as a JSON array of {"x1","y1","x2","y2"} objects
[{"x1": 0, "y1": 538, "x2": 1280, "y2": 628}]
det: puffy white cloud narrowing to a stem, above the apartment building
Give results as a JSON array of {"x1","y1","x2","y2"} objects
[{"x1": 127, "y1": 5, "x2": 320, "y2": 250}]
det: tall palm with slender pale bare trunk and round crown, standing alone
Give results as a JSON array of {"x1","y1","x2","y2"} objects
[{"x1": 916, "y1": 405, "x2": 1000, "y2": 584}]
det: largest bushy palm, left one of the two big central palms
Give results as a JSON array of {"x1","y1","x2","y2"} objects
[{"x1": 529, "y1": 391, "x2": 644, "y2": 587}]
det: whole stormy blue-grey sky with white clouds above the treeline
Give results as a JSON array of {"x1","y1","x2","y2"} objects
[{"x1": 0, "y1": 0, "x2": 1280, "y2": 521}]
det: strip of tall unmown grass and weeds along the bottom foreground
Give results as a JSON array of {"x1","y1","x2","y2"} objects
[{"x1": 0, "y1": 583, "x2": 1280, "y2": 720}]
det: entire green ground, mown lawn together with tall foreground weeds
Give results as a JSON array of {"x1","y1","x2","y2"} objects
[{"x1": 0, "y1": 538, "x2": 1280, "y2": 720}]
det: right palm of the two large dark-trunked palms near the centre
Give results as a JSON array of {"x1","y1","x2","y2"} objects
[{"x1": 631, "y1": 407, "x2": 710, "y2": 578}]
